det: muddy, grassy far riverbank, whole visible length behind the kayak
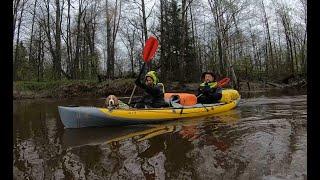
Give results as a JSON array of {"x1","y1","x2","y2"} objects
[{"x1": 13, "y1": 79, "x2": 306, "y2": 100}]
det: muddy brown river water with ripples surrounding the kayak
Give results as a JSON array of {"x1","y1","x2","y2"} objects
[{"x1": 13, "y1": 92, "x2": 307, "y2": 180}]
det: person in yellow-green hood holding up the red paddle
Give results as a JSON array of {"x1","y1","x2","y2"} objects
[{"x1": 134, "y1": 71, "x2": 168, "y2": 108}]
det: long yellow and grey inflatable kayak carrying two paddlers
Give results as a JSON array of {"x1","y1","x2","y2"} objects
[{"x1": 58, "y1": 89, "x2": 240, "y2": 128}]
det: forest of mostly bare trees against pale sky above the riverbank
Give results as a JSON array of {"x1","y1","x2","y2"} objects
[{"x1": 13, "y1": 0, "x2": 307, "y2": 87}]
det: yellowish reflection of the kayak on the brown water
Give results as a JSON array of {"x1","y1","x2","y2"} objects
[{"x1": 63, "y1": 110, "x2": 240, "y2": 148}]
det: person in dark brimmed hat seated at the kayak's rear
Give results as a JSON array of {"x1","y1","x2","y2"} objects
[{"x1": 197, "y1": 72, "x2": 222, "y2": 104}]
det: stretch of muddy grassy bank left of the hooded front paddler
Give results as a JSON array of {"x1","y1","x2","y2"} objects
[{"x1": 13, "y1": 79, "x2": 136, "y2": 100}]
